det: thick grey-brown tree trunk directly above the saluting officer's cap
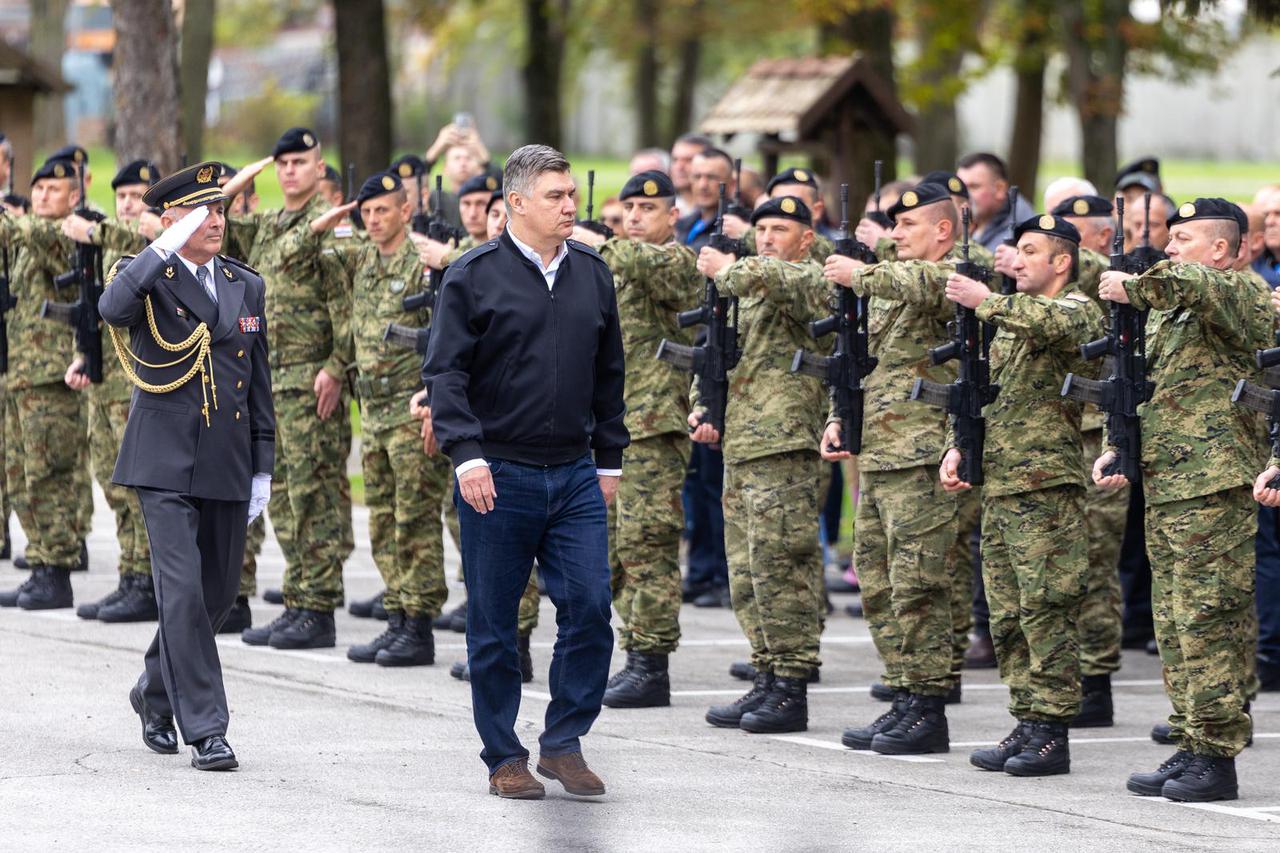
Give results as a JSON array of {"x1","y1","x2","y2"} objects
[{"x1": 111, "y1": 0, "x2": 179, "y2": 173}]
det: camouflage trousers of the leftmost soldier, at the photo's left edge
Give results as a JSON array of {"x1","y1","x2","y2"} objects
[{"x1": 5, "y1": 382, "x2": 86, "y2": 567}]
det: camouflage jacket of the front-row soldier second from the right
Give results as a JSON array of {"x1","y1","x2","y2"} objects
[{"x1": 947, "y1": 283, "x2": 1102, "y2": 497}]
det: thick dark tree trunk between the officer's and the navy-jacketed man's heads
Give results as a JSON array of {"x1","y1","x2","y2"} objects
[{"x1": 333, "y1": 0, "x2": 392, "y2": 185}]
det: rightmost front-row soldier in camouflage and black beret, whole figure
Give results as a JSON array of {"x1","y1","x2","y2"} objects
[{"x1": 1093, "y1": 199, "x2": 1275, "y2": 802}]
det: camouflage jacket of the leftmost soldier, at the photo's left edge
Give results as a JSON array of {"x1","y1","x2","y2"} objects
[{"x1": 0, "y1": 215, "x2": 79, "y2": 391}]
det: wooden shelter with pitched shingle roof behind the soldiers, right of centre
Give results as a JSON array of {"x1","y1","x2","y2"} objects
[{"x1": 700, "y1": 54, "x2": 915, "y2": 211}]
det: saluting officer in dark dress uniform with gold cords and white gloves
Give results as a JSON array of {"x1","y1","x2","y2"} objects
[{"x1": 99, "y1": 163, "x2": 275, "y2": 770}]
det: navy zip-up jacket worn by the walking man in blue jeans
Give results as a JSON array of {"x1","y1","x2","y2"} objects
[{"x1": 422, "y1": 232, "x2": 630, "y2": 469}]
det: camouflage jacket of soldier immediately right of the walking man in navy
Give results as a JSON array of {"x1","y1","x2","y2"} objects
[{"x1": 600, "y1": 238, "x2": 705, "y2": 442}]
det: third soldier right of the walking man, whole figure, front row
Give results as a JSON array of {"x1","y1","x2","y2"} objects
[{"x1": 822, "y1": 183, "x2": 972, "y2": 753}]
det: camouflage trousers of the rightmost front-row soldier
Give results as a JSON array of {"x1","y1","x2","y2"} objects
[{"x1": 1146, "y1": 487, "x2": 1257, "y2": 757}]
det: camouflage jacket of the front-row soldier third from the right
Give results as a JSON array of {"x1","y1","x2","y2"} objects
[{"x1": 852, "y1": 246, "x2": 983, "y2": 471}]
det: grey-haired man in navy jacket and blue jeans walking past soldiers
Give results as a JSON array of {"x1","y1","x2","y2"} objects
[{"x1": 422, "y1": 145, "x2": 630, "y2": 799}]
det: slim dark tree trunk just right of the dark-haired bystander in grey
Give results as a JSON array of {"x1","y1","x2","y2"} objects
[{"x1": 1009, "y1": 0, "x2": 1052, "y2": 201}]
